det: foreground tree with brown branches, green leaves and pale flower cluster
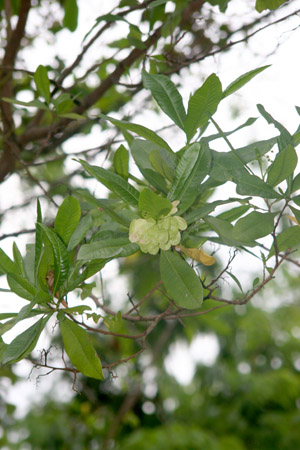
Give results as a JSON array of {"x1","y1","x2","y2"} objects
[{"x1": 0, "y1": 0, "x2": 300, "y2": 394}]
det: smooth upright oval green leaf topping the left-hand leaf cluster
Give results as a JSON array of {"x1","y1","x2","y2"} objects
[{"x1": 54, "y1": 196, "x2": 81, "y2": 245}]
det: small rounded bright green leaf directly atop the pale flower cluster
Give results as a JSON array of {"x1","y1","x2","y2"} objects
[{"x1": 139, "y1": 189, "x2": 172, "y2": 219}]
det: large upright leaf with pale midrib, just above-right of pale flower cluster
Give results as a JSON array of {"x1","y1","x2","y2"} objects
[{"x1": 168, "y1": 142, "x2": 211, "y2": 214}]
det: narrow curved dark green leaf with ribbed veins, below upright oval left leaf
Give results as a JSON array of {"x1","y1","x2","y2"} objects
[{"x1": 37, "y1": 223, "x2": 69, "y2": 294}]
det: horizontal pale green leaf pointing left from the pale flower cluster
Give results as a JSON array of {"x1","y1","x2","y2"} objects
[{"x1": 77, "y1": 237, "x2": 139, "y2": 260}]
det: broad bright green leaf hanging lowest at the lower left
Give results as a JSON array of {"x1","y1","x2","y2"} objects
[{"x1": 59, "y1": 318, "x2": 104, "y2": 380}]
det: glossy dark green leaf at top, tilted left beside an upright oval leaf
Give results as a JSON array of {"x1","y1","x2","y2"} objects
[{"x1": 142, "y1": 70, "x2": 186, "y2": 130}]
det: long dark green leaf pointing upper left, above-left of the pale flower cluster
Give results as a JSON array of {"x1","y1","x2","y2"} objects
[{"x1": 80, "y1": 160, "x2": 140, "y2": 206}]
